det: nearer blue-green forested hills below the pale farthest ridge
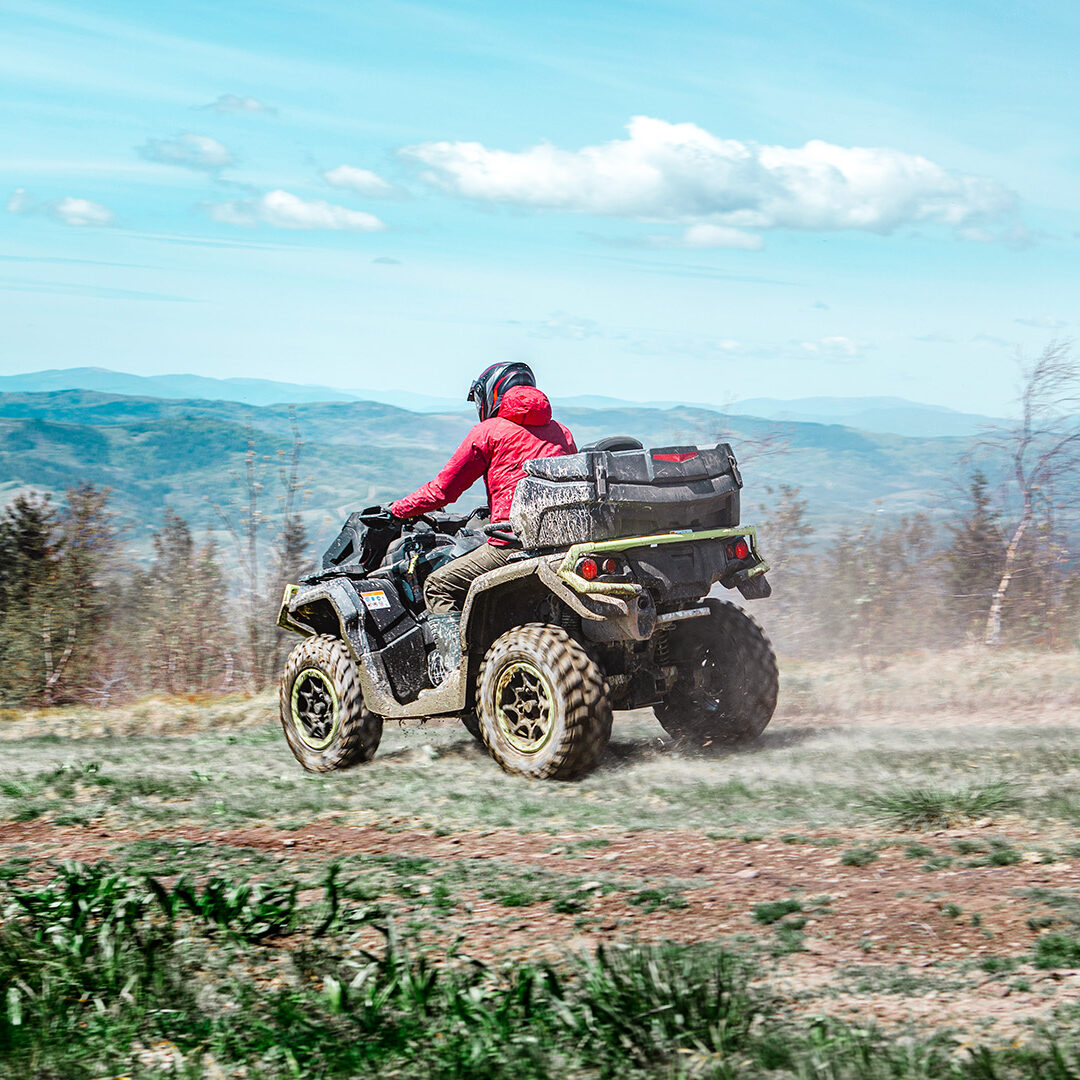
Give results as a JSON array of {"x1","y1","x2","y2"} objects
[{"x1": 0, "y1": 390, "x2": 984, "y2": 561}]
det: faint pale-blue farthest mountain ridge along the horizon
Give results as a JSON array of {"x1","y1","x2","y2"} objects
[{"x1": 0, "y1": 367, "x2": 994, "y2": 436}]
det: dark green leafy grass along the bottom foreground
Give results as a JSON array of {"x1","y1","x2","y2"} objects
[{"x1": 6, "y1": 864, "x2": 1080, "y2": 1080}]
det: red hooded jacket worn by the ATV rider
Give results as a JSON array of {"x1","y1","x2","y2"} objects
[{"x1": 390, "y1": 387, "x2": 578, "y2": 522}]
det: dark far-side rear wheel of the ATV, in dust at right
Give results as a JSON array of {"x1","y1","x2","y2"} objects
[{"x1": 653, "y1": 599, "x2": 779, "y2": 747}]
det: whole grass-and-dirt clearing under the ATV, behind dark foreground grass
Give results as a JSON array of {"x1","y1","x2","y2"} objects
[{"x1": 0, "y1": 652, "x2": 1080, "y2": 1041}]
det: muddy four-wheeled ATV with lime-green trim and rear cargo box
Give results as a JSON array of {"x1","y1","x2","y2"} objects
[{"x1": 279, "y1": 437, "x2": 778, "y2": 779}]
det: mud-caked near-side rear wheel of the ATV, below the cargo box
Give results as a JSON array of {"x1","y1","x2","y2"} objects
[{"x1": 476, "y1": 623, "x2": 611, "y2": 780}]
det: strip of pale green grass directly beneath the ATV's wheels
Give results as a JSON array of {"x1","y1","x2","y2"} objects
[{"x1": 0, "y1": 701, "x2": 1080, "y2": 833}]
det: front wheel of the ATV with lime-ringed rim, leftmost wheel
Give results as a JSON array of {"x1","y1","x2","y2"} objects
[{"x1": 280, "y1": 634, "x2": 382, "y2": 772}]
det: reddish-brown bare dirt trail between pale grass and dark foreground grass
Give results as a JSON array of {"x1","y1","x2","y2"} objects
[{"x1": 6, "y1": 822, "x2": 1080, "y2": 963}]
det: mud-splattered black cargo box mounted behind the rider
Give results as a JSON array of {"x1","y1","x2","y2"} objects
[{"x1": 510, "y1": 443, "x2": 742, "y2": 549}]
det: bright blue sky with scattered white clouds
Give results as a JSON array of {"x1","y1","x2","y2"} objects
[{"x1": 0, "y1": 0, "x2": 1080, "y2": 413}]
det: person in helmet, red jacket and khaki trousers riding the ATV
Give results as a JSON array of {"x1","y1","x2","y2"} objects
[{"x1": 390, "y1": 362, "x2": 577, "y2": 638}]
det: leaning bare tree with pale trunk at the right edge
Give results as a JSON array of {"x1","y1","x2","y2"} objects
[{"x1": 983, "y1": 341, "x2": 1080, "y2": 646}]
